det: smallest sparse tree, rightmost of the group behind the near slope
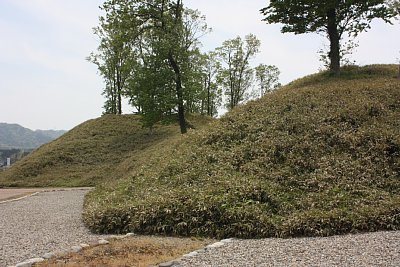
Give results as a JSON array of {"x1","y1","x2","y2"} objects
[{"x1": 255, "y1": 64, "x2": 281, "y2": 97}]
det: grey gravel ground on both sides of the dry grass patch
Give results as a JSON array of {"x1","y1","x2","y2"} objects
[{"x1": 0, "y1": 190, "x2": 400, "y2": 267}]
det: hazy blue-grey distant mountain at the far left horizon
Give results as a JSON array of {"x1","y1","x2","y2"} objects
[{"x1": 0, "y1": 123, "x2": 65, "y2": 149}]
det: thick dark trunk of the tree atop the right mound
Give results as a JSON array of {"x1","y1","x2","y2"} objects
[{"x1": 327, "y1": 8, "x2": 340, "y2": 76}]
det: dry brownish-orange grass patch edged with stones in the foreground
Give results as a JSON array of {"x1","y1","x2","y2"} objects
[{"x1": 36, "y1": 236, "x2": 213, "y2": 267}]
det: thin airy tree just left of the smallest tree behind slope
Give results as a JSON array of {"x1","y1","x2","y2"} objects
[{"x1": 216, "y1": 34, "x2": 261, "y2": 110}]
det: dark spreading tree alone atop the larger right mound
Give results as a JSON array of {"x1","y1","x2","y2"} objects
[{"x1": 261, "y1": 0, "x2": 395, "y2": 75}]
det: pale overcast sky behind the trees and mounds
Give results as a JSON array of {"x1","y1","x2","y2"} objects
[{"x1": 0, "y1": 0, "x2": 400, "y2": 130}]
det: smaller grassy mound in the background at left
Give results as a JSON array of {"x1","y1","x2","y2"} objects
[{"x1": 0, "y1": 115, "x2": 209, "y2": 187}]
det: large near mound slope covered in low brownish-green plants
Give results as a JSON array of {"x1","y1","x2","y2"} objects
[{"x1": 83, "y1": 66, "x2": 400, "y2": 238}]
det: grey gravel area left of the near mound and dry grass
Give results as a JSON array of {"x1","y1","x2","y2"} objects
[{"x1": 0, "y1": 190, "x2": 109, "y2": 267}]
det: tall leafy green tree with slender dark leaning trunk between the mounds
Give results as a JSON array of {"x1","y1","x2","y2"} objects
[{"x1": 92, "y1": 0, "x2": 208, "y2": 133}]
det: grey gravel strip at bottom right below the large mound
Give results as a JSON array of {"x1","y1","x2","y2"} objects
[{"x1": 179, "y1": 231, "x2": 400, "y2": 267}]
